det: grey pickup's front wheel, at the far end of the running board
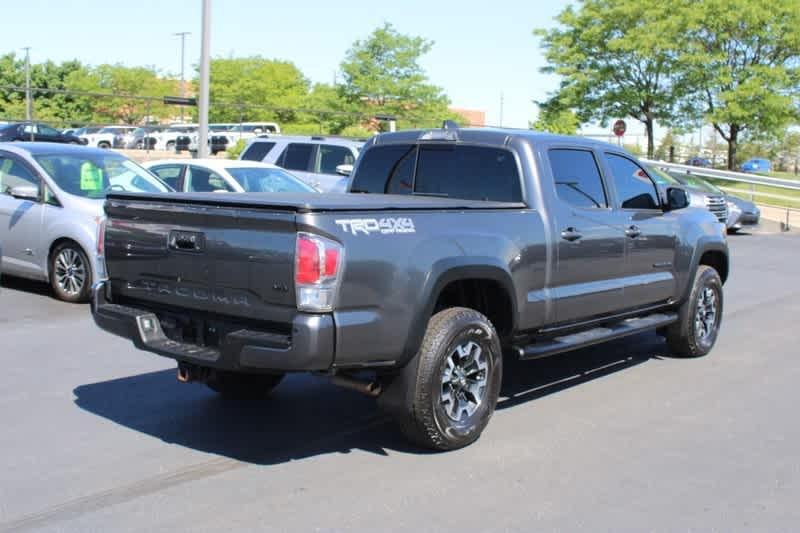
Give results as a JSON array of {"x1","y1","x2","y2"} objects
[{"x1": 665, "y1": 265, "x2": 722, "y2": 357}]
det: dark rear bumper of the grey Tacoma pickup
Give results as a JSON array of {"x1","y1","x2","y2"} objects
[{"x1": 92, "y1": 282, "x2": 335, "y2": 372}]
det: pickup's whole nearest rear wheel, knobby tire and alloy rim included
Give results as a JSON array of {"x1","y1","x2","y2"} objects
[{"x1": 386, "y1": 307, "x2": 503, "y2": 451}]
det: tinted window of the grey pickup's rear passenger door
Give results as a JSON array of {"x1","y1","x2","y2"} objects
[{"x1": 547, "y1": 149, "x2": 608, "y2": 208}]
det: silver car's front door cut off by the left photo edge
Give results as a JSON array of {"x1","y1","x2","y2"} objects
[{"x1": 0, "y1": 152, "x2": 46, "y2": 277}]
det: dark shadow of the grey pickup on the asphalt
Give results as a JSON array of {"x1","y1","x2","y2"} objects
[{"x1": 73, "y1": 333, "x2": 666, "y2": 465}]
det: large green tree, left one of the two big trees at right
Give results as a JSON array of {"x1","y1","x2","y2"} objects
[{"x1": 534, "y1": 0, "x2": 689, "y2": 157}]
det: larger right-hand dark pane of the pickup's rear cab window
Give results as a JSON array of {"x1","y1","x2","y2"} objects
[{"x1": 414, "y1": 145, "x2": 522, "y2": 202}]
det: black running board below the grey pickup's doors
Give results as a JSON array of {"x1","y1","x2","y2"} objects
[{"x1": 515, "y1": 313, "x2": 678, "y2": 359}]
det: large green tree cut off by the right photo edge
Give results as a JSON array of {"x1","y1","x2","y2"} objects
[{"x1": 680, "y1": 0, "x2": 800, "y2": 169}]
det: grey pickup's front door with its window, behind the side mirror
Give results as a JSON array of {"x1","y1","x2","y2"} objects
[{"x1": 603, "y1": 151, "x2": 678, "y2": 307}]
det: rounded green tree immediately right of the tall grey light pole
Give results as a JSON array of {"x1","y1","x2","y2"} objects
[{"x1": 209, "y1": 56, "x2": 309, "y2": 123}]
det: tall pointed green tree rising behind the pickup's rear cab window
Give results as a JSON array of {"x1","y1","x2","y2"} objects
[{"x1": 340, "y1": 23, "x2": 456, "y2": 127}]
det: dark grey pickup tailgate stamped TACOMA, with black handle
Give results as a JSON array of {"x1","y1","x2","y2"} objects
[{"x1": 105, "y1": 198, "x2": 296, "y2": 324}]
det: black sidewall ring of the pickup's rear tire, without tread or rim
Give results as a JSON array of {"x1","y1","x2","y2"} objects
[{"x1": 426, "y1": 313, "x2": 503, "y2": 448}]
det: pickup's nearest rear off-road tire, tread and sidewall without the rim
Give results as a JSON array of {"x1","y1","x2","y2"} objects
[{"x1": 393, "y1": 307, "x2": 503, "y2": 451}]
